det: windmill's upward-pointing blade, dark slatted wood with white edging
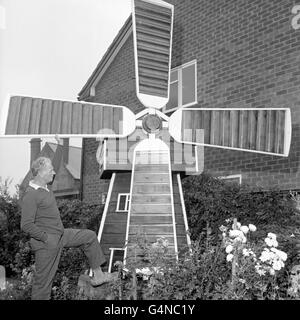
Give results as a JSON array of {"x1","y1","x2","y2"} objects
[{"x1": 132, "y1": 0, "x2": 174, "y2": 109}]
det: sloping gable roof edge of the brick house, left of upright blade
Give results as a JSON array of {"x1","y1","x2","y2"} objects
[{"x1": 78, "y1": 14, "x2": 132, "y2": 100}]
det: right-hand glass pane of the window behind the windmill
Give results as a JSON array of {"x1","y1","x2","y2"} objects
[{"x1": 182, "y1": 64, "x2": 196, "y2": 105}]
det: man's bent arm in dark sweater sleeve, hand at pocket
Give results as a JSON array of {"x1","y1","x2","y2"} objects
[{"x1": 21, "y1": 192, "x2": 48, "y2": 242}]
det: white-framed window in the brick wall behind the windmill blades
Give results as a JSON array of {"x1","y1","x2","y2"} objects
[{"x1": 164, "y1": 60, "x2": 197, "y2": 112}]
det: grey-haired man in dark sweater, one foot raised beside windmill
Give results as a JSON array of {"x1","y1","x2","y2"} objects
[{"x1": 21, "y1": 157, "x2": 116, "y2": 300}]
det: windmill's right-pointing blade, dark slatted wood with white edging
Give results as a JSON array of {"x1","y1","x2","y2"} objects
[{"x1": 169, "y1": 108, "x2": 292, "y2": 157}]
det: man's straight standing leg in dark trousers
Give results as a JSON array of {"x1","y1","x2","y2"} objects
[{"x1": 31, "y1": 235, "x2": 62, "y2": 300}]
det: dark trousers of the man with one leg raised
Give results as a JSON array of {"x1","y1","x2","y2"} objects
[{"x1": 30, "y1": 229, "x2": 106, "y2": 300}]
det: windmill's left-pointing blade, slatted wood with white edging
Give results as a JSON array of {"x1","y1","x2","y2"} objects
[{"x1": 0, "y1": 96, "x2": 135, "y2": 138}]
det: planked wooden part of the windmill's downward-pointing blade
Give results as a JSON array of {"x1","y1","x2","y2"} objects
[{"x1": 125, "y1": 146, "x2": 177, "y2": 261}]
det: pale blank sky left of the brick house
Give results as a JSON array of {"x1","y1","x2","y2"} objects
[{"x1": 0, "y1": 0, "x2": 131, "y2": 194}]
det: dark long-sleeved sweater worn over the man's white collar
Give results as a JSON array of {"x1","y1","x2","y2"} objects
[{"x1": 21, "y1": 186, "x2": 64, "y2": 242}]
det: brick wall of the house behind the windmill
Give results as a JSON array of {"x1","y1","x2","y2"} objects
[{"x1": 80, "y1": 0, "x2": 300, "y2": 204}]
